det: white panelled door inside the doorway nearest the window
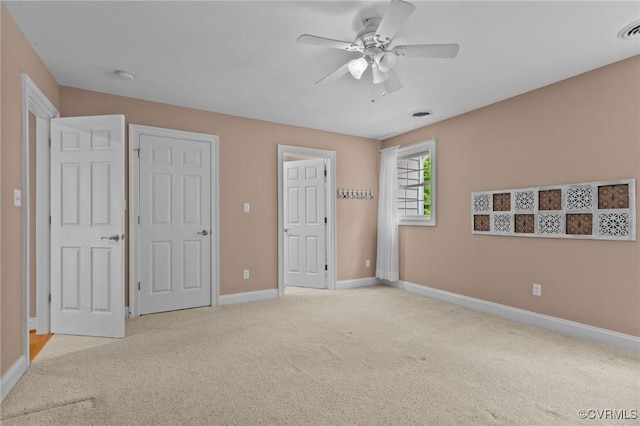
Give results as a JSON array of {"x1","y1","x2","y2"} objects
[{"x1": 283, "y1": 158, "x2": 327, "y2": 288}]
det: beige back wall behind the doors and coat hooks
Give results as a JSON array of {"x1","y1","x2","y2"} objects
[{"x1": 60, "y1": 87, "x2": 380, "y2": 294}]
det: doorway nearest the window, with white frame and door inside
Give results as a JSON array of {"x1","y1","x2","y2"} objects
[{"x1": 278, "y1": 145, "x2": 336, "y2": 297}]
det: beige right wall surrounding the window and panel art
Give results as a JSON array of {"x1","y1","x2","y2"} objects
[{"x1": 383, "y1": 57, "x2": 640, "y2": 336}]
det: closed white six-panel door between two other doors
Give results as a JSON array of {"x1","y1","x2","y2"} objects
[{"x1": 138, "y1": 129, "x2": 213, "y2": 314}]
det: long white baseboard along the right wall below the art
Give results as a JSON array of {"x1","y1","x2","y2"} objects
[{"x1": 400, "y1": 281, "x2": 640, "y2": 351}]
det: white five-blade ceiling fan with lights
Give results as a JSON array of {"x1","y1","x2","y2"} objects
[{"x1": 298, "y1": 0, "x2": 460, "y2": 93}]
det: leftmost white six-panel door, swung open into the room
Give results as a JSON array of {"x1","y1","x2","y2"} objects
[{"x1": 51, "y1": 115, "x2": 125, "y2": 337}]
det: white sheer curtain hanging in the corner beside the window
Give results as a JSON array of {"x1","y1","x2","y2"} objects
[{"x1": 376, "y1": 146, "x2": 399, "y2": 281}]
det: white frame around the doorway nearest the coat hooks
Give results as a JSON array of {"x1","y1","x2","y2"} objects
[{"x1": 277, "y1": 145, "x2": 337, "y2": 297}]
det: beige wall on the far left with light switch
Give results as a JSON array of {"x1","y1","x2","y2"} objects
[{"x1": 0, "y1": 5, "x2": 58, "y2": 373}]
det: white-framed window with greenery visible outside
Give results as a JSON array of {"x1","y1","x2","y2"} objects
[{"x1": 397, "y1": 138, "x2": 436, "y2": 226}]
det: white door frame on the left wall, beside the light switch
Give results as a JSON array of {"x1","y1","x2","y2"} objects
[{"x1": 22, "y1": 73, "x2": 60, "y2": 356}]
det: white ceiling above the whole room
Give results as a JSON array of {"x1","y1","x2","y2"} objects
[{"x1": 4, "y1": 1, "x2": 640, "y2": 139}]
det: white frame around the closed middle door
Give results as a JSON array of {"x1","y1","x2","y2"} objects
[{"x1": 129, "y1": 124, "x2": 220, "y2": 317}]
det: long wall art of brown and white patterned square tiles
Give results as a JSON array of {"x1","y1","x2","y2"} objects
[{"x1": 471, "y1": 179, "x2": 636, "y2": 241}]
